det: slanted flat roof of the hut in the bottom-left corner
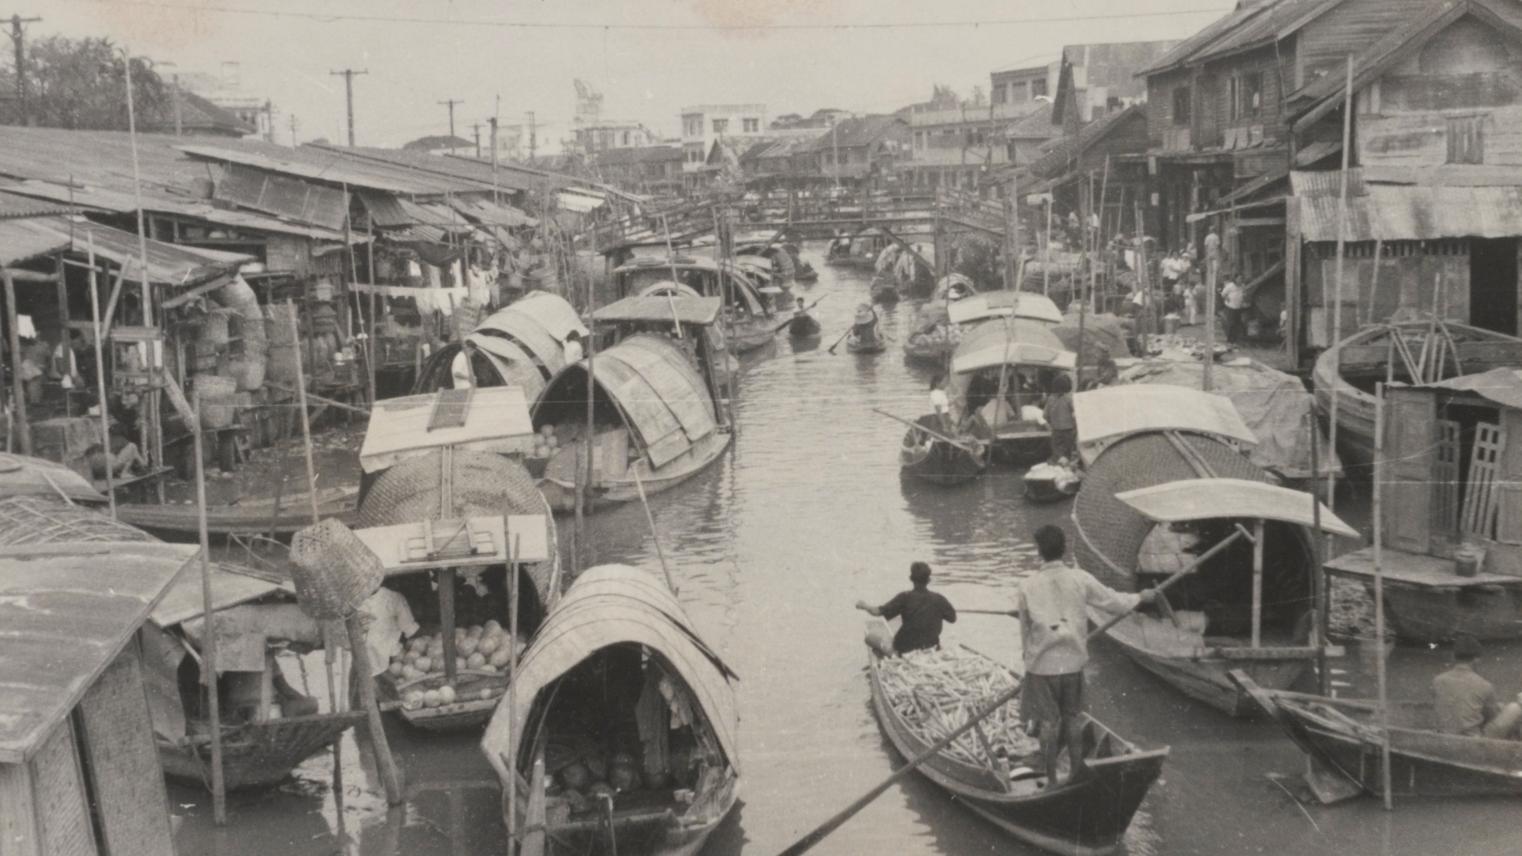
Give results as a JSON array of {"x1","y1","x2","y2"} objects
[{"x1": 0, "y1": 542, "x2": 199, "y2": 763}]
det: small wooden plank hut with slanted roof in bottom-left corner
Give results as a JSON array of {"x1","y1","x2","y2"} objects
[{"x1": 0, "y1": 542, "x2": 198, "y2": 856}]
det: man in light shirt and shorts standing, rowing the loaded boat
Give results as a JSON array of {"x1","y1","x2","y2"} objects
[{"x1": 1009, "y1": 525, "x2": 1157, "y2": 787}]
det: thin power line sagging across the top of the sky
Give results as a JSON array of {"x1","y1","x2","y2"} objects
[{"x1": 53, "y1": 0, "x2": 1222, "y2": 32}]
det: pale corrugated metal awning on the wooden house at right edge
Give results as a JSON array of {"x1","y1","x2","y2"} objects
[{"x1": 1298, "y1": 184, "x2": 1522, "y2": 241}]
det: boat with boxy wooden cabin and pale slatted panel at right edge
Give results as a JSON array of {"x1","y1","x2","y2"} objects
[{"x1": 1327, "y1": 369, "x2": 1522, "y2": 641}]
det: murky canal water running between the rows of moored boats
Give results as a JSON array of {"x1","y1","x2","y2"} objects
[{"x1": 170, "y1": 253, "x2": 1522, "y2": 856}]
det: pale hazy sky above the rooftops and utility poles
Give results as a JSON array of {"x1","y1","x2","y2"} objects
[{"x1": 32, "y1": 0, "x2": 1234, "y2": 152}]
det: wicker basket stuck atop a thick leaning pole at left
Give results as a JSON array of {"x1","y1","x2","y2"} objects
[{"x1": 291, "y1": 518, "x2": 385, "y2": 620}]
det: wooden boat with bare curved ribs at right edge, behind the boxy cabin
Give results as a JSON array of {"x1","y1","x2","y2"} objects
[{"x1": 1310, "y1": 320, "x2": 1522, "y2": 466}]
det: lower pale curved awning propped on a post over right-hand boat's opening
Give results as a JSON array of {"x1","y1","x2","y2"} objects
[{"x1": 1116, "y1": 478, "x2": 1361, "y2": 538}]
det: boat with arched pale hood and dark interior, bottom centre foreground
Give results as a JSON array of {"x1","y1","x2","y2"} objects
[{"x1": 481, "y1": 565, "x2": 740, "y2": 856}]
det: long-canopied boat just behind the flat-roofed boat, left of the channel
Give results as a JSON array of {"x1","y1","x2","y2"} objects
[{"x1": 612, "y1": 256, "x2": 778, "y2": 353}]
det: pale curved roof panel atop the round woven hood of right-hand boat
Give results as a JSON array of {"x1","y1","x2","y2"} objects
[{"x1": 1073, "y1": 384, "x2": 1257, "y2": 457}]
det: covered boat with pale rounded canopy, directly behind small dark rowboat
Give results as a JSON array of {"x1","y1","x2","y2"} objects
[{"x1": 948, "y1": 316, "x2": 1073, "y2": 466}]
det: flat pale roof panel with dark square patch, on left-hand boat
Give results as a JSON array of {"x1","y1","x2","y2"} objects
[{"x1": 359, "y1": 387, "x2": 534, "y2": 472}]
